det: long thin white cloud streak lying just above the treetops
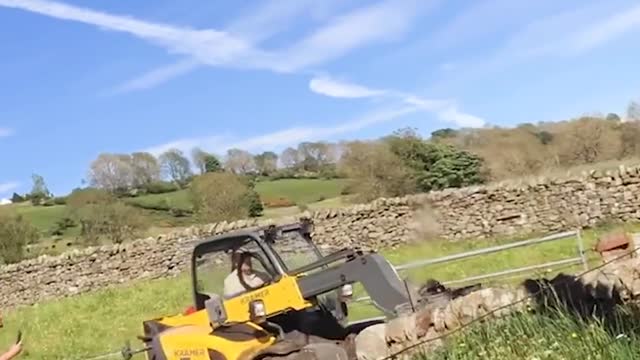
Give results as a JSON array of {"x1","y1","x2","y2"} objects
[{"x1": 144, "y1": 105, "x2": 420, "y2": 155}]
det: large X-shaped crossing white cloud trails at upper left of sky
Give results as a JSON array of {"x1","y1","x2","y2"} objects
[{"x1": 0, "y1": 0, "x2": 436, "y2": 92}]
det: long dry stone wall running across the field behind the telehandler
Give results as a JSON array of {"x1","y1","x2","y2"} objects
[{"x1": 0, "y1": 167, "x2": 640, "y2": 308}]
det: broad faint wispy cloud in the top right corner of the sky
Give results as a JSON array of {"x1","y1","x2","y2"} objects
[{"x1": 428, "y1": 0, "x2": 640, "y2": 97}]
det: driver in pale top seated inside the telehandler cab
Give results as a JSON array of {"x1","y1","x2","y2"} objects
[{"x1": 223, "y1": 251, "x2": 269, "y2": 299}]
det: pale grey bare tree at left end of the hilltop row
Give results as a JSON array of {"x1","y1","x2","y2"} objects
[{"x1": 88, "y1": 153, "x2": 134, "y2": 193}]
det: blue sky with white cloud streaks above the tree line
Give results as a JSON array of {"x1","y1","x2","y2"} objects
[{"x1": 0, "y1": 0, "x2": 640, "y2": 197}]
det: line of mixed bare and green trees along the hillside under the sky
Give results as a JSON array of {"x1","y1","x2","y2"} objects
[{"x1": 0, "y1": 103, "x2": 640, "y2": 261}]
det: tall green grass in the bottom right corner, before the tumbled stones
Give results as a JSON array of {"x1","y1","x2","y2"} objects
[{"x1": 424, "y1": 309, "x2": 640, "y2": 360}]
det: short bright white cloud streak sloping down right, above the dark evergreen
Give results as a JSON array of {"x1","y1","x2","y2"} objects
[{"x1": 309, "y1": 76, "x2": 486, "y2": 127}]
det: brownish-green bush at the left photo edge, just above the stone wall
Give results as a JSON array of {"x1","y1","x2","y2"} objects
[{"x1": 0, "y1": 214, "x2": 39, "y2": 264}]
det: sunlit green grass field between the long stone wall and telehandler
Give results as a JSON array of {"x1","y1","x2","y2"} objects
[{"x1": 0, "y1": 225, "x2": 639, "y2": 359}]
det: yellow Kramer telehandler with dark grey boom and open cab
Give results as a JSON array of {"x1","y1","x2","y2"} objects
[{"x1": 128, "y1": 220, "x2": 438, "y2": 360}]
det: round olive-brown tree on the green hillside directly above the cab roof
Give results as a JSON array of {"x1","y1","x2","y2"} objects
[{"x1": 189, "y1": 172, "x2": 251, "y2": 223}]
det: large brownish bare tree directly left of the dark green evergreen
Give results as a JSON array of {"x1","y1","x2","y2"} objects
[{"x1": 339, "y1": 141, "x2": 415, "y2": 202}]
